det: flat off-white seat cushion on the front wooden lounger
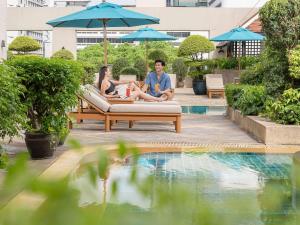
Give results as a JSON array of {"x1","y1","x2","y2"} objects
[{"x1": 109, "y1": 104, "x2": 181, "y2": 113}]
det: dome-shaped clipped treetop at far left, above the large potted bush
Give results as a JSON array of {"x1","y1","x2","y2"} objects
[{"x1": 8, "y1": 36, "x2": 41, "y2": 54}]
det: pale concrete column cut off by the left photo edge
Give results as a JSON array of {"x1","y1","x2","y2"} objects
[{"x1": 0, "y1": 0, "x2": 7, "y2": 61}]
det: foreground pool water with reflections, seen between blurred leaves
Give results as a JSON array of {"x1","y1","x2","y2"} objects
[{"x1": 74, "y1": 152, "x2": 292, "y2": 224}]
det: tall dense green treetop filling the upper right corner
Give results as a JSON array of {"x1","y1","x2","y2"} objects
[{"x1": 259, "y1": 0, "x2": 300, "y2": 50}]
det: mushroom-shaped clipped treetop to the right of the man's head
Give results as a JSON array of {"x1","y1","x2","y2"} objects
[{"x1": 178, "y1": 35, "x2": 215, "y2": 61}]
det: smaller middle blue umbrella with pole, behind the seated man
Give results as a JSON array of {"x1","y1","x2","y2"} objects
[{"x1": 120, "y1": 27, "x2": 176, "y2": 70}]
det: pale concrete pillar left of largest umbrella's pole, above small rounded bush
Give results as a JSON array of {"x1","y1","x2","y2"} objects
[{"x1": 52, "y1": 28, "x2": 77, "y2": 59}]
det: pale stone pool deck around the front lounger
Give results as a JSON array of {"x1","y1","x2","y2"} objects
[{"x1": 0, "y1": 89, "x2": 300, "y2": 183}]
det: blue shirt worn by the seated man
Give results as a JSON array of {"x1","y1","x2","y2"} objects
[{"x1": 145, "y1": 72, "x2": 171, "y2": 96}]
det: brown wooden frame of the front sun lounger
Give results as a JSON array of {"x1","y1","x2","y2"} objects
[{"x1": 69, "y1": 96, "x2": 181, "y2": 133}]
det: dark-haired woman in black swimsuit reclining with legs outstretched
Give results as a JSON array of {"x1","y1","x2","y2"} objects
[{"x1": 99, "y1": 66, "x2": 165, "y2": 102}]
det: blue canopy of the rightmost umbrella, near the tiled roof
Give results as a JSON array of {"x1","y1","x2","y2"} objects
[{"x1": 210, "y1": 27, "x2": 265, "y2": 42}]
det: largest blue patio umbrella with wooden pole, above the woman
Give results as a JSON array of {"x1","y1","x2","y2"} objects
[{"x1": 47, "y1": 1, "x2": 159, "y2": 65}]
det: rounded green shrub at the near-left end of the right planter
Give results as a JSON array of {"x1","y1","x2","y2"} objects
[{"x1": 233, "y1": 85, "x2": 267, "y2": 116}]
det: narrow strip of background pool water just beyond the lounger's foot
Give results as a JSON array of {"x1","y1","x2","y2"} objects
[{"x1": 181, "y1": 106, "x2": 226, "y2": 115}]
